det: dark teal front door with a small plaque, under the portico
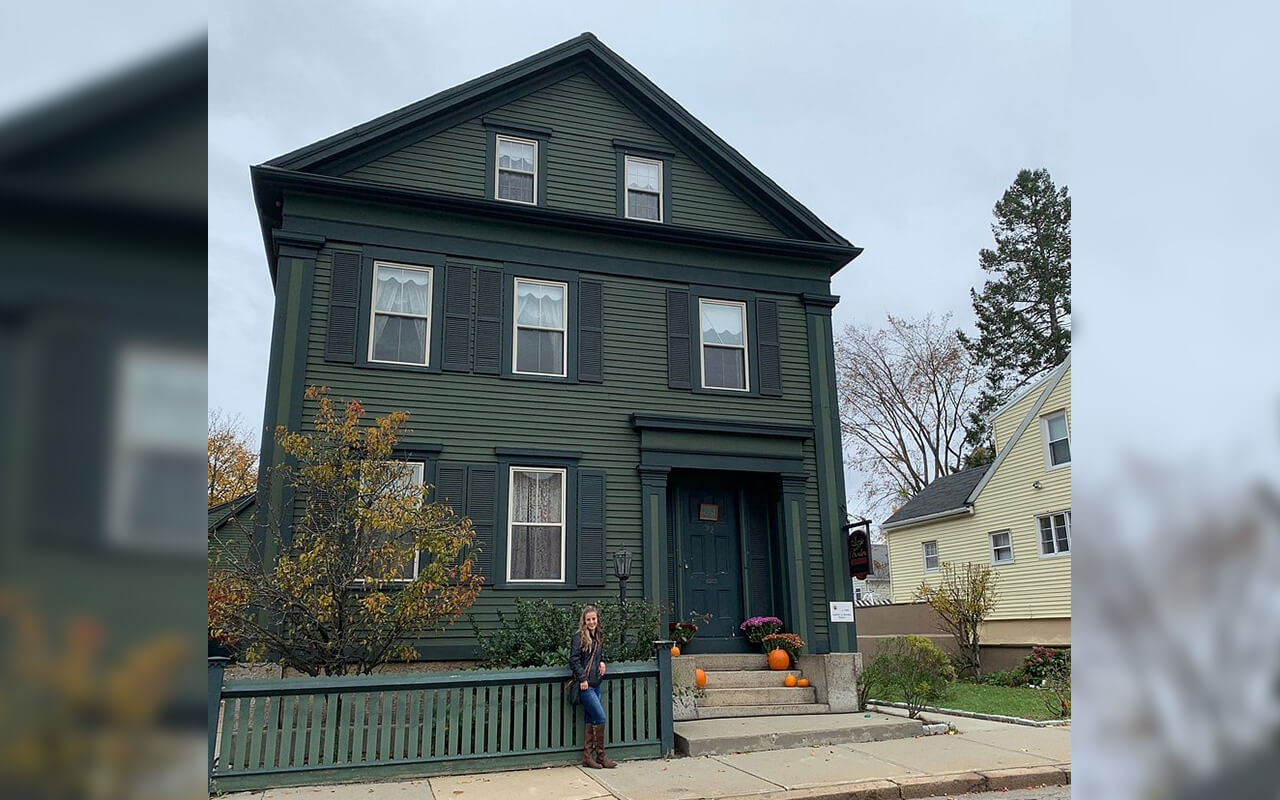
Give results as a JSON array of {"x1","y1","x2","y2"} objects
[{"x1": 677, "y1": 486, "x2": 742, "y2": 639}]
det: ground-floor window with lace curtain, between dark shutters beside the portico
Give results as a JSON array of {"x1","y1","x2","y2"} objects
[{"x1": 507, "y1": 467, "x2": 566, "y2": 582}]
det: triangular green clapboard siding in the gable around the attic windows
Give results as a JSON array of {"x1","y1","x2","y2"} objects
[{"x1": 344, "y1": 74, "x2": 783, "y2": 237}]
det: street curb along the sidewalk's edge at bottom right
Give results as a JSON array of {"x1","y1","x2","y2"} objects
[{"x1": 716, "y1": 764, "x2": 1071, "y2": 800}]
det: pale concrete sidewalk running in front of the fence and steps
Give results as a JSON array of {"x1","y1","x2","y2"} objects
[{"x1": 225, "y1": 714, "x2": 1071, "y2": 800}]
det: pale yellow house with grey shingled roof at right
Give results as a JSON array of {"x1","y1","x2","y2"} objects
[{"x1": 881, "y1": 356, "x2": 1071, "y2": 660}]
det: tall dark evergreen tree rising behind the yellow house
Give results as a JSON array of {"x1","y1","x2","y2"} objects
[{"x1": 957, "y1": 169, "x2": 1071, "y2": 466}]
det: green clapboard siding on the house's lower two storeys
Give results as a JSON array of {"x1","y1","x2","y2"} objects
[{"x1": 295, "y1": 247, "x2": 827, "y2": 645}]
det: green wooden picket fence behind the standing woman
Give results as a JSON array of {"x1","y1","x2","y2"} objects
[{"x1": 209, "y1": 643, "x2": 673, "y2": 792}]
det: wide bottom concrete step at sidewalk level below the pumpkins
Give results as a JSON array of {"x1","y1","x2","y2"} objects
[{"x1": 676, "y1": 709, "x2": 924, "y2": 755}]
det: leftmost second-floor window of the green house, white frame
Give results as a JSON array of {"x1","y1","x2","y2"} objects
[{"x1": 369, "y1": 261, "x2": 433, "y2": 365}]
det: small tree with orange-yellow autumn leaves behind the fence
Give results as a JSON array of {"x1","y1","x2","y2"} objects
[{"x1": 209, "y1": 387, "x2": 483, "y2": 676}]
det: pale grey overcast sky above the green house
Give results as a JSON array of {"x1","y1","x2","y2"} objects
[{"x1": 209, "y1": 1, "x2": 1071, "y2": 473}]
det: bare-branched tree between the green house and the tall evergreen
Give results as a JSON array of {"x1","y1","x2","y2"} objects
[{"x1": 836, "y1": 314, "x2": 982, "y2": 509}]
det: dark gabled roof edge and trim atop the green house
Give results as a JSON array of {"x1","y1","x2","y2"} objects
[{"x1": 252, "y1": 33, "x2": 861, "y2": 271}]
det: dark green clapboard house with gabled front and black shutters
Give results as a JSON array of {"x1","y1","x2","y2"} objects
[{"x1": 252, "y1": 33, "x2": 860, "y2": 659}]
